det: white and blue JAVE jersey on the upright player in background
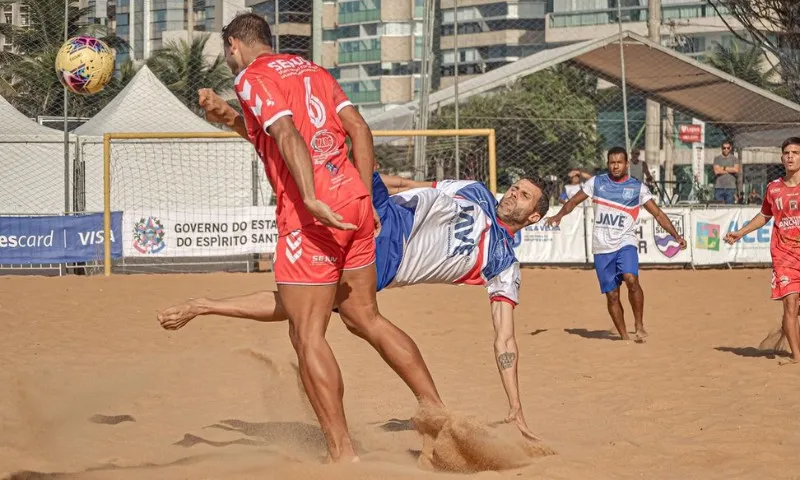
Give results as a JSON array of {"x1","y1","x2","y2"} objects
[{"x1": 583, "y1": 174, "x2": 653, "y2": 254}]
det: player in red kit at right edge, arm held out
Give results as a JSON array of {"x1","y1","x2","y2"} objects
[{"x1": 725, "y1": 137, "x2": 800, "y2": 362}]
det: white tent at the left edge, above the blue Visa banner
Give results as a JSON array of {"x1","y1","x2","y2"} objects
[{"x1": 0, "y1": 97, "x2": 74, "y2": 215}]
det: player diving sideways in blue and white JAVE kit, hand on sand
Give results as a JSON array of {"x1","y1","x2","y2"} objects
[{"x1": 158, "y1": 173, "x2": 549, "y2": 438}]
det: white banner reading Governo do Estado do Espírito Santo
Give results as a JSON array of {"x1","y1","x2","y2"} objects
[{"x1": 122, "y1": 206, "x2": 278, "y2": 257}]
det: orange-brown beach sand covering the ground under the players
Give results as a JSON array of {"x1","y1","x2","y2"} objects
[{"x1": 0, "y1": 269, "x2": 800, "y2": 480}]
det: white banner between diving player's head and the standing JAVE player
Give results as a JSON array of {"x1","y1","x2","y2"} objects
[{"x1": 514, "y1": 205, "x2": 586, "y2": 263}]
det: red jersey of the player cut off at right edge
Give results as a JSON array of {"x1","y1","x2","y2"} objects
[{"x1": 761, "y1": 178, "x2": 800, "y2": 269}]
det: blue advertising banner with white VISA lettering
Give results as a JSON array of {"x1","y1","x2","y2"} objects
[{"x1": 0, "y1": 212, "x2": 122, "y2": 265}]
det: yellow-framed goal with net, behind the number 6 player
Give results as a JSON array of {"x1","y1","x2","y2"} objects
[{"x1": 103, "y1": 129, "x2": 497, "y2": 276}]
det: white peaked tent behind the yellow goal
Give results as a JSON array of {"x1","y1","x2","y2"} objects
[{"x1": 75, "y1": 65, "x2": 266, "y2": 211}]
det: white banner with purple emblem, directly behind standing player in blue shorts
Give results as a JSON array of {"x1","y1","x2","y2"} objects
[{"x1": 586, "y1": 208, "x2": 692, "y2": 264}]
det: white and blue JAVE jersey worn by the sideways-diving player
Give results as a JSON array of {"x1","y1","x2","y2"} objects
[{"x1": 388, "y1": 180, "x2": 520, "y2": 304}]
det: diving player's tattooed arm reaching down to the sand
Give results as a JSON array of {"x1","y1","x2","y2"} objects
[{"x1": 492, "y1": 299, "x2": 538, "y2": 440}]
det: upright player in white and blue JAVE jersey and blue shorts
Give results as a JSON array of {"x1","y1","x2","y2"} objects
[{"x1": 545, "y1": 147, "x2": 686, "y2": 341}]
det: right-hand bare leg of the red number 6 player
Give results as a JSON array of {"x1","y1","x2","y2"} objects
[{"x1": 337, "y1": 263, "x2": 444, "y2": 407}]
